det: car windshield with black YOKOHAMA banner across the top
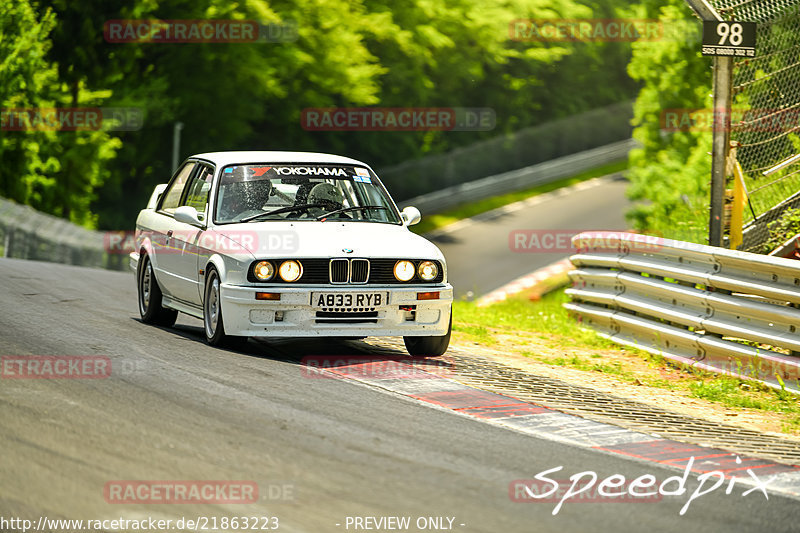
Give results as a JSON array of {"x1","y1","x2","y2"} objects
[{"x1": 214, "y1": 163, "x2": 402, "y2": 224}]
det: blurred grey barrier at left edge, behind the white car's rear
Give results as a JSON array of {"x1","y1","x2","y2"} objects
[{"x1": 0, "y1": 198, "x2": 125, "y2": 270}]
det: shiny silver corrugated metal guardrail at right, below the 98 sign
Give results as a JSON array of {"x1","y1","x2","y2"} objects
[{"x1": 564, "y1": 232, "x2": 800, "y2": 394}]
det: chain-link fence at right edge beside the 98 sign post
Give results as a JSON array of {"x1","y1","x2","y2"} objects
[{"x1": 711, "y1": 0, "x2": 800, "y2": 252}]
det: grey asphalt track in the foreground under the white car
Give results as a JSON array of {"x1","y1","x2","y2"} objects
[{"x1": 0, "y1": 259, "x2": 800, "y2": 533}]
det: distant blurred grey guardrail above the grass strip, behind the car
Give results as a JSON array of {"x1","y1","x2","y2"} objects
[{"x1": 400, "y1": 139, "x2": 639, "y2": 214}]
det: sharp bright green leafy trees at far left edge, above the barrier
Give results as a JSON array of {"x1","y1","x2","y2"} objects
[{"x1": 0, "y1": 0, "x2": 120, "y2": 226}]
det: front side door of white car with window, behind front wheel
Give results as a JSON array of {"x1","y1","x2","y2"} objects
[{"x1": 167, "y1": 163, "x2": 214, "y2": 306}]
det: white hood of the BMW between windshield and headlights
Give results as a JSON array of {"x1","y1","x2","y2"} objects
[{"x1": 213, "y1": 221, "x2": 444, "y2": 261}]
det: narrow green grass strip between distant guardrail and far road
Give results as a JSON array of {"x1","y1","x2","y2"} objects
[{"x1": 410, "y1": 159, "x2": 628, "y2": 234}]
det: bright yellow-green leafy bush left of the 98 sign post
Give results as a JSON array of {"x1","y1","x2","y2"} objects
[{"x1": 628, "y1": 0, "x2": 712, "y2": 242}]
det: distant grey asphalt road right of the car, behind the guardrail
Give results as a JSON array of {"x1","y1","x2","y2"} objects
[{"x1": 432, "y1": 174, "x2": 630, "y2": 297}]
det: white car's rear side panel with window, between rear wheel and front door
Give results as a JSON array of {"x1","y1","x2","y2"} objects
[{"x1": 151, "y1": 161, "x2": 198, "y2": 299}]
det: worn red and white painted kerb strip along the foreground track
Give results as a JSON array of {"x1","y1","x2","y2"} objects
[{"x1": 306, "y1": 357, "x2": 800, "y2": 498}]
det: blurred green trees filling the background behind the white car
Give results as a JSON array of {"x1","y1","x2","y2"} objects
[{"x1": 0, "y1": 0, "x2": 636, "y2": 229}]
